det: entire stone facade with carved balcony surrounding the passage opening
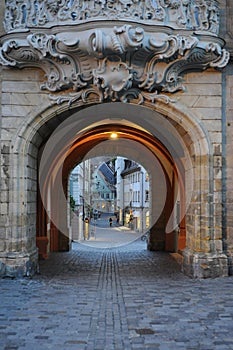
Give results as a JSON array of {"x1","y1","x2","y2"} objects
[{"x1": 0, "y1": 0, "x2": 233, "y2": 278}]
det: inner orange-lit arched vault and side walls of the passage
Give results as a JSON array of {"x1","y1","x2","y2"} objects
[{"x1": 38, "y1": 120, "x2": 185, "y2": 251}]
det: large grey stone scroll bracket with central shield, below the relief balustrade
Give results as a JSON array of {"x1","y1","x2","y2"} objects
[{"x1": 0, "y1": 24, "x2": 229, "y2": 104}]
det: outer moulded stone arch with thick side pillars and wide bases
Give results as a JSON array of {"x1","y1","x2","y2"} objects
[{"x1": 3, "y1": 102, "x2": 227, "y2": 277}]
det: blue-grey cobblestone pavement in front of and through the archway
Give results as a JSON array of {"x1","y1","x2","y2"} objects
[{"x1": 0, "y1": 240, "x2": 233, "y2": 350}]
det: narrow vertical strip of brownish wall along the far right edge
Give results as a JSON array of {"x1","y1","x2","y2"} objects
[{"x1": 220, "y1": 0, "x2": 233, "y2": 274}]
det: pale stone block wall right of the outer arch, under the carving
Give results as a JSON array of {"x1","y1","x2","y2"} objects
[{"x1": 180, "y1": 70, "x2": 222, "y2": 252}]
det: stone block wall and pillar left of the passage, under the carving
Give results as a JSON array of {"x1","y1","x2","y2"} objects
[{"x1": 0, "y1": 68, "x2": 47, "y2": 276}]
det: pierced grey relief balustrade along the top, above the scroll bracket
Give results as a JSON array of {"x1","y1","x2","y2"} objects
[{"x1": 4, "y1": 0, "x2": 219, "y2": 34}]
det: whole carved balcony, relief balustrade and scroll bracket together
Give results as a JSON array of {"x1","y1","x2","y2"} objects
[{"x1": 0, "y1": 0, "x2": 229, "y2": 103}]
